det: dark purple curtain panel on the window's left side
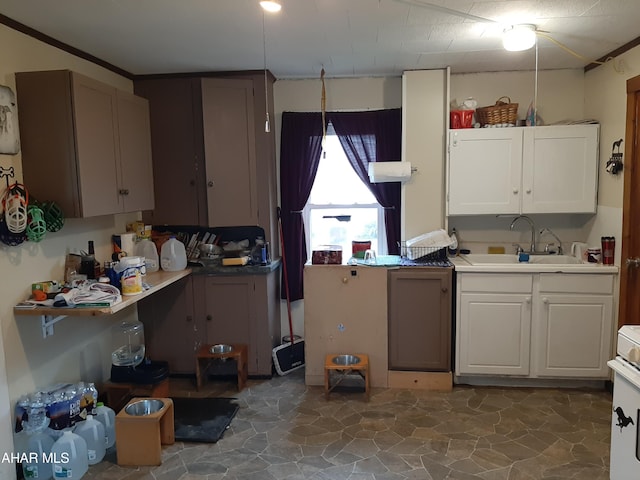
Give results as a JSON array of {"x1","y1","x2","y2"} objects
[{"x1": 280, "y1": 112, "x2": 322, "y2": 301}]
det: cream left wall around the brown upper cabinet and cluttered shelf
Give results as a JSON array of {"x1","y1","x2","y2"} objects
[{"x1": 0, "y1": 25, "x2": 137, "y2": 479}]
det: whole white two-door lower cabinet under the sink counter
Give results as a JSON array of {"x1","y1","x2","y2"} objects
[{"x1": 456, "y1": 273, "x2": 614, "y2": 379}]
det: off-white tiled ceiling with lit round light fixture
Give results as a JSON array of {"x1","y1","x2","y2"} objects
[{"x1": 0, "y1": 0, "x2": 640, "y2": 78}]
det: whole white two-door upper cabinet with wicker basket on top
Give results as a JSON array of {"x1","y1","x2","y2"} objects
[{"x1": 447, "y1": 125, "x2": 599, "y2": 215}]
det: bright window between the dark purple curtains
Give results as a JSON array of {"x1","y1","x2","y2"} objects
[{"x1": 303, "y1": 124, "x2": 387, "y2": 261}]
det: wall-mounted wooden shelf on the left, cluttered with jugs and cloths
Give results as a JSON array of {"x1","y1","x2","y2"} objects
[{"x1": 13, "y1": 269, "x2": 191, "y2": 338}]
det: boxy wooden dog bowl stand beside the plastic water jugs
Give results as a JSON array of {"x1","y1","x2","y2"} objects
[{"x1": 116, "y1": 397, "x2": 175, "y2": 466}]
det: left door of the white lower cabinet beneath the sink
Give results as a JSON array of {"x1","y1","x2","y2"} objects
[{"x1": 456, "y1": 293, "x2": 531, "y2": 376}]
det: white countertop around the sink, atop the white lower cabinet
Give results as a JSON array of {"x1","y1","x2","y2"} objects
[{"x1": 450, "y1": 255, "x2": 618, "y2": 274}]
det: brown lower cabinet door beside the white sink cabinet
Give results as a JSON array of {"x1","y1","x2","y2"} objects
[{"x1": 388, "y1": 267, "x2": 453, "y2": 372}]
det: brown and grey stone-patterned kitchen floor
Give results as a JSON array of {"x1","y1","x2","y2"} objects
[{"x1": 83, "y1": 370, "x2": 611, "y2": 480}]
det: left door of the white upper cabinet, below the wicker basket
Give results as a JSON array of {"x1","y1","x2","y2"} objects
[{"x1": 447, "y1": 128, "x2": 522, "y2": 215}]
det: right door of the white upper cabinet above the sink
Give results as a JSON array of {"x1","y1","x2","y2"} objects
[{"x1": 524, "y1": 125, "x2": 599, "y2": 213}]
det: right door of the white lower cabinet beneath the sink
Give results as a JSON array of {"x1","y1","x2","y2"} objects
[{"x1": 535, "y1": 293, "x2": 613, "y2": 378}]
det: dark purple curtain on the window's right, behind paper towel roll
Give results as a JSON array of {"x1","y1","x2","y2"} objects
[{"x1": 326, "y1": 108, "x2": 402, "y2": 255}]
